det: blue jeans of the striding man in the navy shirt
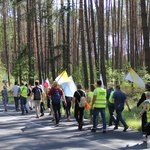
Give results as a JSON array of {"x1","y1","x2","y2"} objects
[{"x1": 116, "y1": 108, "x2": 127, "y2": 127}]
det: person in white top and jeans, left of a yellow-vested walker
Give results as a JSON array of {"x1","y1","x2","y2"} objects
[{"x1": 11, "y1": 82, "x2": 20, "y2": 111}]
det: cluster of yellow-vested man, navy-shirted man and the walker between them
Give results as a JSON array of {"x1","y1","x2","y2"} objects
[{"x1": 86, "y1": 80, "x2": 130, "y2": 133}]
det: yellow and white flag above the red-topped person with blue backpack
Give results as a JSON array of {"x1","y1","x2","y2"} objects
[{"x1": 55, "y1": 70, "x2": 70, "y2": 84}]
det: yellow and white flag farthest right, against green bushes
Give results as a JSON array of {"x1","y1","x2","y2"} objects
[{"x1": 125, "y1": 68, "x2": 145, "y2": 88}]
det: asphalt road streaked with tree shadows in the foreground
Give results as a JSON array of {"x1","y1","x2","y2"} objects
[{"x1": 0, "y1": 101, "x2": 150, "y2": 150}]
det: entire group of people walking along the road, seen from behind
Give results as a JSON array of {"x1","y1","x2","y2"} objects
[{"x1": 1, "y1": 80, "x2": 150, "y2": 140}]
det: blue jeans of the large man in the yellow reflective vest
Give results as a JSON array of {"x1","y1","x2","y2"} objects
[{"x1": 93, "y1": 108, "x2": 106, "y2": 130}]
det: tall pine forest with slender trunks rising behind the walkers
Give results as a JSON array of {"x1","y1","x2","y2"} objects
[{"x1": 0, "y1": 0, "x2": 150, "y2": 88}]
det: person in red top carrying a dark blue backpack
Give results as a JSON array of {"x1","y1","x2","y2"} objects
[{"x1": 48, "y1": 81, "x2": 66, "y2": 126}]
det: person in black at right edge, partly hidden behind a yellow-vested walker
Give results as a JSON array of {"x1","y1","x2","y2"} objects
[{"x1": 137, "y1": 82, "x2": 150, "y2": 134}]
